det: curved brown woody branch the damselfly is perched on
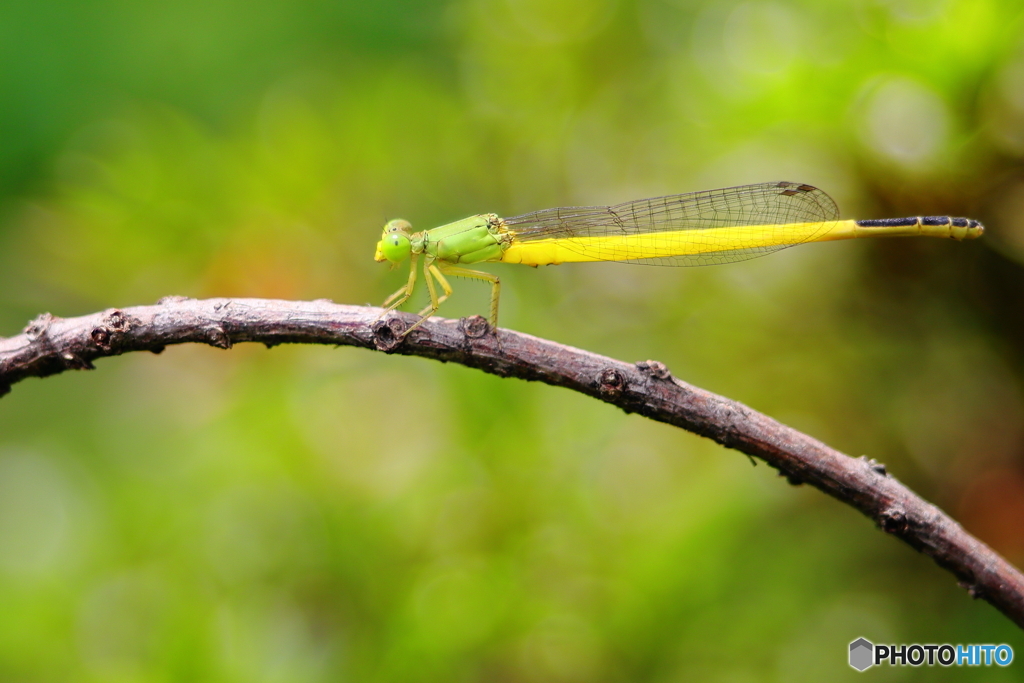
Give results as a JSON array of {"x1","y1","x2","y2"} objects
[{"x1": 0, "y1": 297, "x2": 1024, "y2": 628}]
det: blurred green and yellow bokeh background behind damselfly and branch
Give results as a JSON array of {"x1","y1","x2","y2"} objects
[{"x1": 0, "y1": 0, "x2": 1024, "y2": 683}]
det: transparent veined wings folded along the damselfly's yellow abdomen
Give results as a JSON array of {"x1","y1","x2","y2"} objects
[{"x1": 503, "y1": 182, "x2": 839, "y2": 265}]
